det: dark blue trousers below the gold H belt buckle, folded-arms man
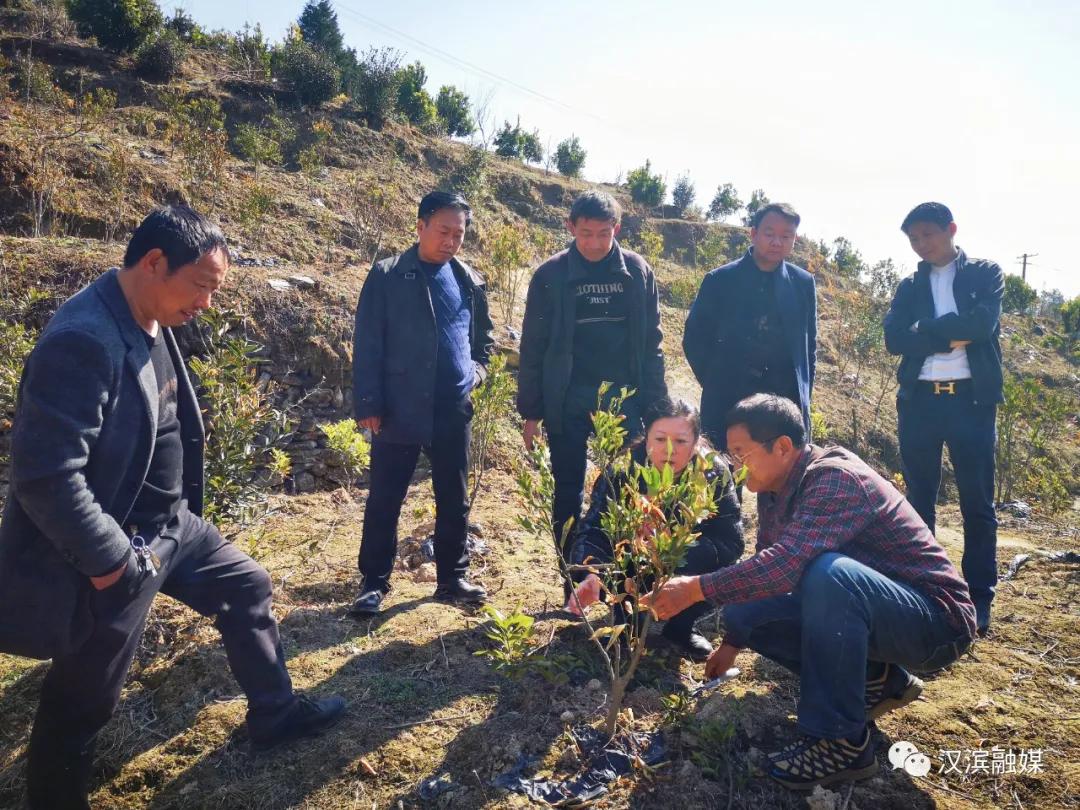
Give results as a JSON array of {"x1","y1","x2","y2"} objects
[{"x1": 896, "y1": 383, "x2": 998, "y2": 605}]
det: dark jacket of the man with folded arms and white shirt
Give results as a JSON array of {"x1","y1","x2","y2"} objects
[{"x1": 885, "y1": 251, "x2": 1005, "y2": 403}]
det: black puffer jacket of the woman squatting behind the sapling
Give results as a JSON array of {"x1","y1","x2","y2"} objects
[{"x1": 570, "y1": 444, "x2": 744, "y2": 576}]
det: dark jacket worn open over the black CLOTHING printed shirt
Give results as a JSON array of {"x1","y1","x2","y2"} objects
[{"x1": 517, "y1": 244, "x2": 667, "y2": 433}]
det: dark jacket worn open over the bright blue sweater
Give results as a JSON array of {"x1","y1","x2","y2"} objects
[{"x1": 352, "y1": 245, "x2": 495, "y2": 445}]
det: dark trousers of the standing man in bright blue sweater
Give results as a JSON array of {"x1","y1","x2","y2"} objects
[{"x1": 359, "y1": 399, "x2": 472, "y2": 591}]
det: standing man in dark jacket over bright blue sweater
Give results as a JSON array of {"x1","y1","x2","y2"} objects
[{"x1": 350, "y1": 191, "x2": 495, "y2": 616}]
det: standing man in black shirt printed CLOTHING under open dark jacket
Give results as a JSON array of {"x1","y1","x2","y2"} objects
[{"x1": 517, "y1": 191, "x2": 667, "y2": 570}]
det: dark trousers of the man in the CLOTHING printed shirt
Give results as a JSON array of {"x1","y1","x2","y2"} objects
[{"x1": 548, "y1": 386, "x2": 643, "y2": 559}]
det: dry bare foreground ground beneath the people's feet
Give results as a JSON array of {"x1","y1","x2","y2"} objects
[{"x1": 0, "y1": 471, "x2": 1080, "y2": 810}]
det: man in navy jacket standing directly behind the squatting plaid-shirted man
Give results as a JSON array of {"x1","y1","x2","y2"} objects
[{"x1": 683, "y1": 203, "x2": 818, "y2": 449}]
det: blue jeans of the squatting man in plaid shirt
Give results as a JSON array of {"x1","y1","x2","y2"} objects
[{"x1": 723, "y1": 553, "x2": 969, "y2": 740}]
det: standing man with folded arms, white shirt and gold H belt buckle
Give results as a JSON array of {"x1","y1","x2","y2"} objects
[{"x1": 885, "y1": 202, "x2": 1004, "y2": 635}]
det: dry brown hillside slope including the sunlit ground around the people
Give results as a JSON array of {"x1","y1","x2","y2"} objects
[{"x1": 0, "y1": 19, "x2": 1080, "y2": 810}]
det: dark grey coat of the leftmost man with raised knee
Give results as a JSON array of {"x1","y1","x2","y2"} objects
[{"x1": 0, "y1": 270, "x2": 203, "y2": 658}]
